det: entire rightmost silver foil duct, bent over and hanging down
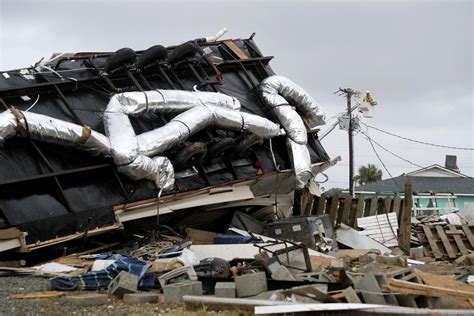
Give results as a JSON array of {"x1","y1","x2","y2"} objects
[{"x1": 259, "y1": 76, "x2": 325, "y2": 189}]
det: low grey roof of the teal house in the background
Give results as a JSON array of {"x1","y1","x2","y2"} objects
[{"x1": 355, "y1": 175, "x2": 474, "y2": 195}]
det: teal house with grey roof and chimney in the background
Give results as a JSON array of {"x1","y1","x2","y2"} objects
[{"x1": 355, "y1": 155, "x2": 474, "y2": 215}]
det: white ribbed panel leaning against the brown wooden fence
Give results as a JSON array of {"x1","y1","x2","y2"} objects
[{"x1": 357, "y1": 212, "x2": 398, "y2": 247}]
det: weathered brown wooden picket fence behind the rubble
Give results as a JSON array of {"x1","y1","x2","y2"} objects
[{"x1": 296, "y1": 193, "x2": 403, "y2": 228}]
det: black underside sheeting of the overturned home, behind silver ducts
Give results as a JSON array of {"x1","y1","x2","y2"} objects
[{"x1": 0, "y1": 40, "x2": 329, "y2": 242}]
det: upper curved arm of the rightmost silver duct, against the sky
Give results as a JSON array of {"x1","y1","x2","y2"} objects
[{"x1": 259, "y1": 76, "x2": 326, "y2": 128}]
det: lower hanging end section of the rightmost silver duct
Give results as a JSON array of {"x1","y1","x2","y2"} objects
[{"x1": 286, "y1": 138, "x2": 313, "y2": 189}]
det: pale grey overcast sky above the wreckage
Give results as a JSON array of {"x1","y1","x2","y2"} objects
[{"x1": 0, "y1": 0, "x2": 474, "y2": 188}]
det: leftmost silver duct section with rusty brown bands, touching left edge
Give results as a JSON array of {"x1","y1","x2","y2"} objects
[{"x1": 0, "y1": 109, "x2": 110, "y2": 156}]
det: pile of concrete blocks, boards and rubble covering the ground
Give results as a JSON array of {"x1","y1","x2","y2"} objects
[{"x1": 1, "y1": 207, "x2": 474, "y2": 314}]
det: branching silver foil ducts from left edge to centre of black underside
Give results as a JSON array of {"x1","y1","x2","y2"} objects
[{"x1": 0, "y1": 90, "x2": 282, "y2": 190}]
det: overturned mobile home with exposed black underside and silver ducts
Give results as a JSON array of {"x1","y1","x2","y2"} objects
[{"x1": 0, "y1": 30, "x2": 337, "y2": 251}]
